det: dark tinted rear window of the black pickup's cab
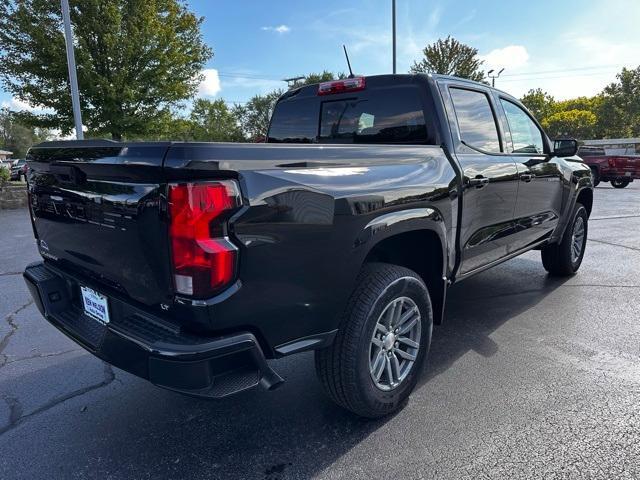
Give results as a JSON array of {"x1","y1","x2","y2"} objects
[{"x1": 269, "y1": 87, "x2": 429, "y2": 144}]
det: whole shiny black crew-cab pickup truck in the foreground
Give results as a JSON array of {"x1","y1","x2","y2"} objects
[{"x1": 24, "y1": 75, "x2": 593, "y2": 417}]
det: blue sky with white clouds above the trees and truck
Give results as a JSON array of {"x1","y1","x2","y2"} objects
[{"x1": 0, "y1": 0, "x2": 640, "y2": 112}]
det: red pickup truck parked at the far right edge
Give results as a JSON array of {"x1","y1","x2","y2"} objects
[{"x1": 578, "y1": 146, "x2": 640, "y2": 188}]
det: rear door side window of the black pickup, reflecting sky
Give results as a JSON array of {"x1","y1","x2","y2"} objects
[{"x1": 450, "y1": 88, "x2": 500, "y2": 152}]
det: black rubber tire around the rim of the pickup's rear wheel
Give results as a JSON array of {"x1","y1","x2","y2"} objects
[{"x1": 315, "y1": 263, "x2": 433, "y2": 418}]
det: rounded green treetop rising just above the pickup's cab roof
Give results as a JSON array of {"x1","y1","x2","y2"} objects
[{"x1": 410, "y1": 36, "x2": 485, "y2": 82}]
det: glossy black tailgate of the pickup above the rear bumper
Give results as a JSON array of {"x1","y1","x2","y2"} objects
[{"x1": 27, "y1": 141, "x2": 172, "y2": 305}]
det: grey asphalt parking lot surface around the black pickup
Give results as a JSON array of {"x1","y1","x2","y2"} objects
[{"x1": 0, "y1": 182, "x2": 640, "y2": 480}]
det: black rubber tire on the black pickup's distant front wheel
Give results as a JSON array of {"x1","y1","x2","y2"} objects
[{"x1": 541, "y1": 203, "x2": 589, "y2": 276}]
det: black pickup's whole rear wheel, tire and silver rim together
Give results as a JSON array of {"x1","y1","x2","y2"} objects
[{"x1": 315, "y1": 263, "x2": 433, "y2": 418}]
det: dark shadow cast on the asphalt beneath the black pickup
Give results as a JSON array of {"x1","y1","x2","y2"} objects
[{"x1": 0, "y1": 257, "x2": 563, "y2": 480}]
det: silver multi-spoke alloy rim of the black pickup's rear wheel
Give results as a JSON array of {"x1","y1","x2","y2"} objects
[{"x1": 369, "y1": 297, "x2": 422, "y2": 391}]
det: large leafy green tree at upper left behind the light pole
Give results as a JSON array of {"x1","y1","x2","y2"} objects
[{"x1": 0, "y1": 0, "x2": 212, "y2": 140}]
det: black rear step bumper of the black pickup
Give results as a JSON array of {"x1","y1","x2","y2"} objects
[{"x1": 24, "y1": 263, "x2": 283, "y2": 398}]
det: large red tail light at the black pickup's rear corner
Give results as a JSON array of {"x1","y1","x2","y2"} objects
[{"x1": 169, "y1": 180, "x2": 242, "y2": 298}]
